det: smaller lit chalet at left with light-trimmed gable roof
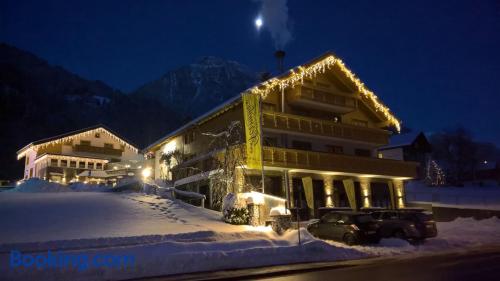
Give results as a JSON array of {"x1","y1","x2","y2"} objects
[{"x1": 17, "y1": 125, "x2": 143, "y2": 184}]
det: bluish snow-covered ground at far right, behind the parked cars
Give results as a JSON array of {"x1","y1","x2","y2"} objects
[{"x1": 405, "y1": 181, "x2": 500, "y2": 210}]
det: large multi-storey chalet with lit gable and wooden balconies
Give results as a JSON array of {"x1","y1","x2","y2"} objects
[{"x1": 144, "y1": 51, "x2": 417, "y2": 216}]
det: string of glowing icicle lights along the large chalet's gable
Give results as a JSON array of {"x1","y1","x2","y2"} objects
[{"x1": 248, "y1": 55, "x2": 401, "y2": 132}]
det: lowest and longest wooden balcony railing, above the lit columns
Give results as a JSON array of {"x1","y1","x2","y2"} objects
[{"x1": 263, "y1": 146, "x2": 418, "y2": 178}]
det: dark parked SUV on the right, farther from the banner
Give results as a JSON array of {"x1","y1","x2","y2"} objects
[{"x1": 371, "y1": 210, "x2": 437, "y2": 241}]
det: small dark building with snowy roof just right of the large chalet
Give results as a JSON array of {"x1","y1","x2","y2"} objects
[{"x1": 378, "y1": 132, "x2": 432, "y2": 179}]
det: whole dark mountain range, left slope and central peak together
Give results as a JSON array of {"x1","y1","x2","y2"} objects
[{"x1": 0, "y1": 43, "x2": 257, "y2": 179}]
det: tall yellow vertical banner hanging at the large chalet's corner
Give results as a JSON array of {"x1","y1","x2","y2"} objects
[{"x1": 243, "y1": 94, "x2": 262, "y2": 170}]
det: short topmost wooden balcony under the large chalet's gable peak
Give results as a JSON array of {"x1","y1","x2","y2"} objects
[{"x1": 289, "y1": 86, "x2": 357, "y2": 113}]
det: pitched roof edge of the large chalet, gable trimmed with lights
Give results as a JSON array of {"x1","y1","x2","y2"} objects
[{"x1": 143, "y1": 52, "x2": 400, "y2": 151}]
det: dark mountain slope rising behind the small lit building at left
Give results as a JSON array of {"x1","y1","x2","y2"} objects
[{"x1": 0, "y1": 44, "x2": 180, "y2": 179}]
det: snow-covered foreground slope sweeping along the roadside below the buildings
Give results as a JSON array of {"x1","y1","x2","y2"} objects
[{"x1": 0, "y1": 178, "x2": 500, "y2": 280}]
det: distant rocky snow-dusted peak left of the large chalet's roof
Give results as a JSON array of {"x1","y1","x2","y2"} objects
[{"x1": 131, "y1": 56, "x2": 258, "y2": 119}]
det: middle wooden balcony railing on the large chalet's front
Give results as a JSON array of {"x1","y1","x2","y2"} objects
[{"x1": 262, "y1": 111, "x2": 389, "y2": 145}]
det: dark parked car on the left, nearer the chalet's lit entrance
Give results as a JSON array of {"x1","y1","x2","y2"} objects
[{"x1": 307, "y1": 211, "x2": 380, "y2": 245}]
